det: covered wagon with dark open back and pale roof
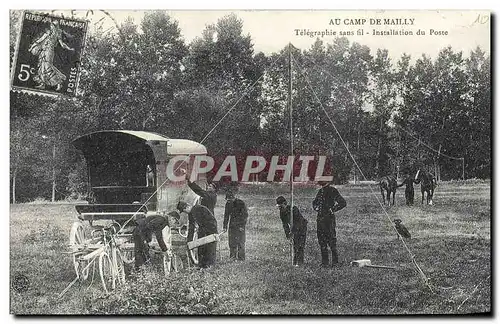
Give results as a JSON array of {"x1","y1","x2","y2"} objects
[{"x1": 69, "y1": 130, "x2": 207, "y2": 291}]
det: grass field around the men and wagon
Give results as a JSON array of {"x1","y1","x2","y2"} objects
[{"x1": 10, "y1": 181, "x2": 491, "y2": 315}]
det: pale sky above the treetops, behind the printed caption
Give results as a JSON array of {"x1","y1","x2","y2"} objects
[{"x1": 42, "y1": 10, "x2": 490, "y2": 59}]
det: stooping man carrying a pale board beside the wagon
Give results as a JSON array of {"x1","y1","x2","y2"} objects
[{"x1": 177, "y1": 201, "x2": 217, "y2": 268}]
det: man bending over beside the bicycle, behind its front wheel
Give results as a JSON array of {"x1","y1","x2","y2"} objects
[{"x1": 132, "y1": 215, "x2": 169, "y2": 269}]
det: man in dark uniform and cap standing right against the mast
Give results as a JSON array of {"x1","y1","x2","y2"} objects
[{"x1": 276, "y1": 196, "x2": 307, "y2": 266}]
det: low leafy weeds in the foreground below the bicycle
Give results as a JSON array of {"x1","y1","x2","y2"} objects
[{"x1": 85, "y1": 269, "x2": 229, "y2": 315}]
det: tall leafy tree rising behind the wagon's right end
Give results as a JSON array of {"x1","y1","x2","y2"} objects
[{"x1": 182, "y1": 14, "x2": 263, "y2": 157}]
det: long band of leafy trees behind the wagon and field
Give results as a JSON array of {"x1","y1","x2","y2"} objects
[{"x1": 10, "y1": 11, "x2": 491, "y2": 202}]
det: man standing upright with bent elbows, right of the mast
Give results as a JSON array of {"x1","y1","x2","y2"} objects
[{"x1": 313, "y1": 181, "x2": 346, "y2": 266}]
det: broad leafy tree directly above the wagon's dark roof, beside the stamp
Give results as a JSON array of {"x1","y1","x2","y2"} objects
[{"x1": 82, "y1": 11, "x2": 187, "y2": 131}]
